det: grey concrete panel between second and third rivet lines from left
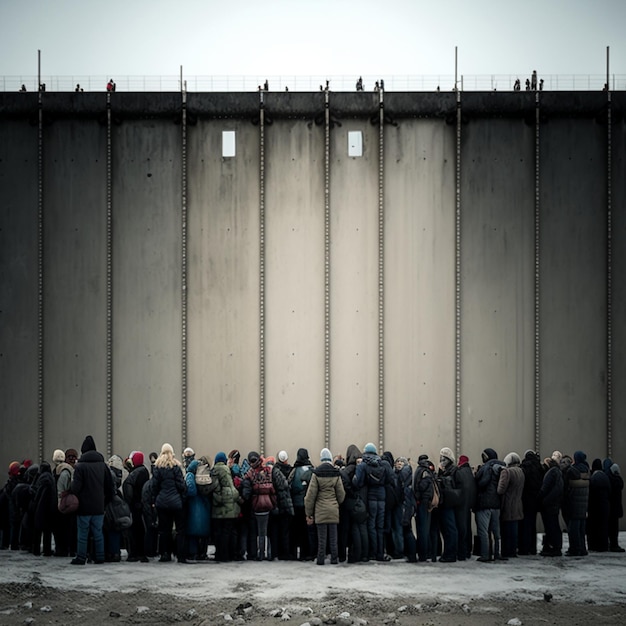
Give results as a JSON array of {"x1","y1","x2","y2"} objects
[{"x1": 112, "y1": 120, "x2": 182, "y2": 455}]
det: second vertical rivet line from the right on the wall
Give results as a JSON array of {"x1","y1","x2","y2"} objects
[{"x1": 535, "y1": 91, "x2": 541, "y2": 452}]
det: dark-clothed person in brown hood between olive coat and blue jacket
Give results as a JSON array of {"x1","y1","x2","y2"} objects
[{"x1": 339, "y1": 444, "x2": 369, "y2": 563}]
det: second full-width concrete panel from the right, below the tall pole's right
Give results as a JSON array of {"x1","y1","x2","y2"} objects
[{"x1": 457, "y1": 119, "x2": 535, "y2": 462}]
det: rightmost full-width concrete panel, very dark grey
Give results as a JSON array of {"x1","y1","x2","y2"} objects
[{"x1": 539, "y1": 119, "x2": 606, "y2": 457}]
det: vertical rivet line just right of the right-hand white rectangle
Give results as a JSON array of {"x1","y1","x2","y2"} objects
[{"x1": 378, "y1": 88, "x2": 385, "y2": 450}]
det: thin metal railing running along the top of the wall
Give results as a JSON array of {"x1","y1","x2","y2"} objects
[{"x1": 0, "y1": 73, "x2": 626, "y2": 92}]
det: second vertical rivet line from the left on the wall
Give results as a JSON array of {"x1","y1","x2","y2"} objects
[{"x1": 106, "y1": 92, "x2": 113, "y2": 456}]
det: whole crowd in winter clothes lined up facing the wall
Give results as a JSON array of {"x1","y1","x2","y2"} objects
[{"x1": 0, "y1": 436, "x2": 624, "y2": 565}]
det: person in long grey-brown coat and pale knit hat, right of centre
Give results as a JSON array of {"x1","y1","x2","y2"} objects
[{"x1": 497, "y1": 452, "x2": 525, "y2": 559}]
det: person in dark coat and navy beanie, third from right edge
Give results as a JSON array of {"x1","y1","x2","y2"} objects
[{"x1": 563, "y1": 450, "x2": 590, "y2": 556}]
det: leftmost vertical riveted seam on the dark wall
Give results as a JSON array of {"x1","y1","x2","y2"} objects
[{"x1": 37, "y1": 86, "x2": 44, "y2": 461}]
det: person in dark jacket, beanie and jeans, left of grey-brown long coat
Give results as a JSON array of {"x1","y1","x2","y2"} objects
[{"x1": 475, "y1": 448, "x2": 504, "y2": 563}]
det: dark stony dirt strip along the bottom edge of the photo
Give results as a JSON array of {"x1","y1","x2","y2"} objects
[{"x1": 0, "y1": 582, "x2": 626, "y2": 626}]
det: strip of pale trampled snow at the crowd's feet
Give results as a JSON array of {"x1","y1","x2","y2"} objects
[{"x1": 0, "y1": 533, "x2": 626, "y2": 604}]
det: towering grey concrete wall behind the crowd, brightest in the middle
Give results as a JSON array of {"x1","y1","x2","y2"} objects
[{"x1": 0, "y1": 86, "x2": 626, "y2": 465}]
